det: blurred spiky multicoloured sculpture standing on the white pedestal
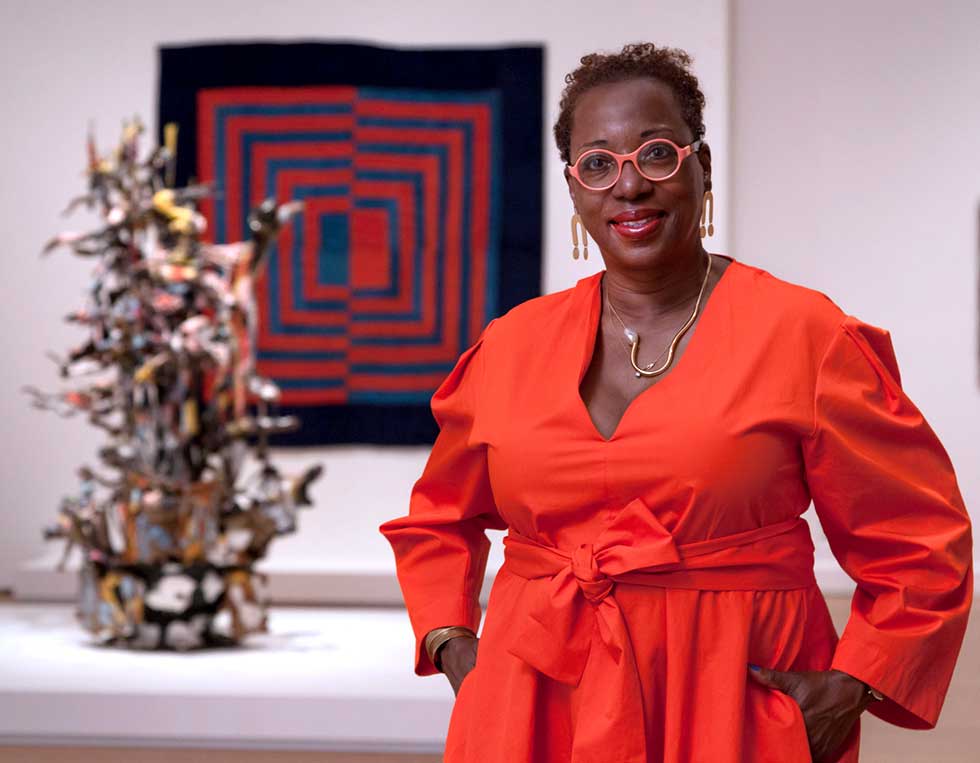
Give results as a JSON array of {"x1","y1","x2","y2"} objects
[{"x1": 25, "y1": 120, "x2": 322, "y2": 650}]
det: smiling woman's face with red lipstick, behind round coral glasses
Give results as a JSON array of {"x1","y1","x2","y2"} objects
[{"x1": 565, "y1": 79, "x2": 711, "y2": 269}]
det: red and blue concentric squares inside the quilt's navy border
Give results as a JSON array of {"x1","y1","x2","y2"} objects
[{"x1": 197, "y1": 86, "x2": 500, "y2": 407}]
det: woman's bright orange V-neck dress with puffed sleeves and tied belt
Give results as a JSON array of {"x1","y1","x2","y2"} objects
[{"x1": 380, "y1": 257, "x2": 973, "y2": 763}]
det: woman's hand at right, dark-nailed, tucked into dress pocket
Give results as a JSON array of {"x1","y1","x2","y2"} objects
[{"x1": 749, "y1": 667, "x2": 871, "y2": 763}]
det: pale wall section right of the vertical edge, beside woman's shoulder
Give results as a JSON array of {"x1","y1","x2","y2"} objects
[{"x1": 731, "y1": 0, "x2": 980, "y2": 572}]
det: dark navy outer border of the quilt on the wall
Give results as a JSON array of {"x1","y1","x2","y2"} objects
[{"x1": 157, "y1": 42, "x2": 544, "y2": 446}]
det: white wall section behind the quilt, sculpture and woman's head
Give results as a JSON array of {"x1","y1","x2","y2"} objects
[{"x1": 0, "y1": 0, "x2": 731, "y2": 587}]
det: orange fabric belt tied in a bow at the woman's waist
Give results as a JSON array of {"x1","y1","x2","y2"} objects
[{"x1": 503, "y1": 499, "x2": 816, "y2": 763}]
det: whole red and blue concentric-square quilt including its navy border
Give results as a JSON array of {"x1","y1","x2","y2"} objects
[{"x1": 159, "y1": 43, "x2": 543, "y2": 445}]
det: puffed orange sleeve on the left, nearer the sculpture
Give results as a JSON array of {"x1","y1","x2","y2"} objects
[{"x1": 379, "y1": 321, "x2": 507, "y2": 676}]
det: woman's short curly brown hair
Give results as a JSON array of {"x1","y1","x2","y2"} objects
[{"x1": 554, "y1": 42, "x2": 704, "y2": 164}]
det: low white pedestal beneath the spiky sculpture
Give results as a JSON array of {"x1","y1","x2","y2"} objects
[{"x1": 0, "y1": 604, "x2": 454, "y2": 753}]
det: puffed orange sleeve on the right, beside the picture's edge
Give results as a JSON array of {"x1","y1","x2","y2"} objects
[{"x1": 803, "y1": 316, "x2": 973, "y2": 729}]
